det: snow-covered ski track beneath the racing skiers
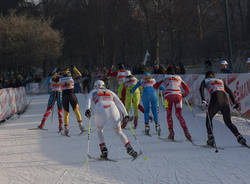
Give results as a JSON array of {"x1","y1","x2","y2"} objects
[{"x1": 0, "y1": 95, "x2": 250, "y2": 184}]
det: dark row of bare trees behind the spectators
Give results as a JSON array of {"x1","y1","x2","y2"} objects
[{"x1": 0, "y1": 0, "x2": 250, "y2": 75}]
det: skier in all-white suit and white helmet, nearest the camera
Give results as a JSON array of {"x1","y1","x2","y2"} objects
[{"x1": 85, "y1": 80, "x2": 138, "y2": 158}]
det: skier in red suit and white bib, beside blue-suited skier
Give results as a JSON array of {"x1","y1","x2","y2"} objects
[{"x1": 154, "y1": 66, "x2": 191, "y2": 140}]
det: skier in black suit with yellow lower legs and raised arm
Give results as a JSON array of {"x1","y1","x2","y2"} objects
[{"x1": 60, "y1": 65, "x2": 84, "y2": 136}]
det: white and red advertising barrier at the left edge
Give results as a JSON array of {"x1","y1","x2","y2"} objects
[{"x1": 0, "y1": 87, "x2": 28, "y2": 121}]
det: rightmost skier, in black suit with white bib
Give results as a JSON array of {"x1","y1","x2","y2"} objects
[{"x1": 200, "y1": 71, "x2": 246, "y2": 146}]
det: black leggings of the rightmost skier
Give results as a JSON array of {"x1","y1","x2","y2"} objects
[{"x1": 206, "y1": 91, "x2": 239, "y2": 136}]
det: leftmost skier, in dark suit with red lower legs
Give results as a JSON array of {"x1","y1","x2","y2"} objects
[{"x1": 38, "y1": 69, "x2": 63, "y2": 132}]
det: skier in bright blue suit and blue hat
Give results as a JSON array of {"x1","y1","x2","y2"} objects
[{"x1": 130, "y1": 72, "x2": 161, "y2": 135}]
